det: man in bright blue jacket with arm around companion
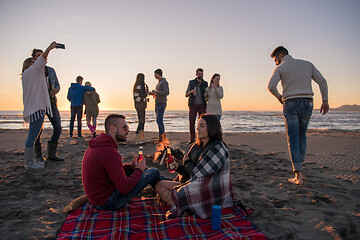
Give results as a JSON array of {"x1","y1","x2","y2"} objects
[{"x1": 67, "y1": 76, "x2": 95, "y2": 137}]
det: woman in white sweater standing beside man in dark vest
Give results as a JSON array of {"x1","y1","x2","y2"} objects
[{"x1": 205, "y1": 73, "x2": 224, "y2": 120}]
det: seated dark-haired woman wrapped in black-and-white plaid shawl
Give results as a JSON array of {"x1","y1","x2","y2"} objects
[{"x1": 155, "y1": 114, "x2": 234, "y2": 219}]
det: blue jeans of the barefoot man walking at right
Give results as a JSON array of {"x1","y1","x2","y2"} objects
[{"x1": 283, "y1": 98, "x2": 313, "y2": 172}]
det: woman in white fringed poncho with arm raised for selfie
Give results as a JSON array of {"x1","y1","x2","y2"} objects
[{"x1": 21, "y1": 42, "x2": 56, "y2": 170}]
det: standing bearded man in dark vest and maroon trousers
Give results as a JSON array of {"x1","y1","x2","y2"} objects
[{"x1": 185, "y1": 68, "x2": 208, "y2": 145}]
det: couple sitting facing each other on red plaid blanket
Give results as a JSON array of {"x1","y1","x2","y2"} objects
[{"x1": 82, "y1": 114, "x2": 233, "y2": 218}]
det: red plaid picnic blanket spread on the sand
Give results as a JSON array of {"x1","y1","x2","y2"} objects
[{"x1": 57, "y1": 198, "x2": 268, "y2": 240}]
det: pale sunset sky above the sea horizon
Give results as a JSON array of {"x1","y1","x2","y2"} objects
[{"x1": 0, "y1": 0, "x2": 360, "y2": 111}]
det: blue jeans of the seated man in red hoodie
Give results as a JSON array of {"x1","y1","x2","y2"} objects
[{"x1": 96, "y1": 168, "x2": 161, "y2": 211}]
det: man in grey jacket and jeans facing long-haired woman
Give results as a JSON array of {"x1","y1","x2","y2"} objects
[{"x1": 151, "y1": 69, "x2": 170, "y2": 142}]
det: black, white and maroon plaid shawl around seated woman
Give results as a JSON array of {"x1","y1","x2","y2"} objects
[{"x1": 168, "y1": 142, "x2": 234, "y2": 219}]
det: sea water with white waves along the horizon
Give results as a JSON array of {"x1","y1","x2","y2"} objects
[{"x1": 0, "y1": 110, "x2": 360, "y2": 133}]
